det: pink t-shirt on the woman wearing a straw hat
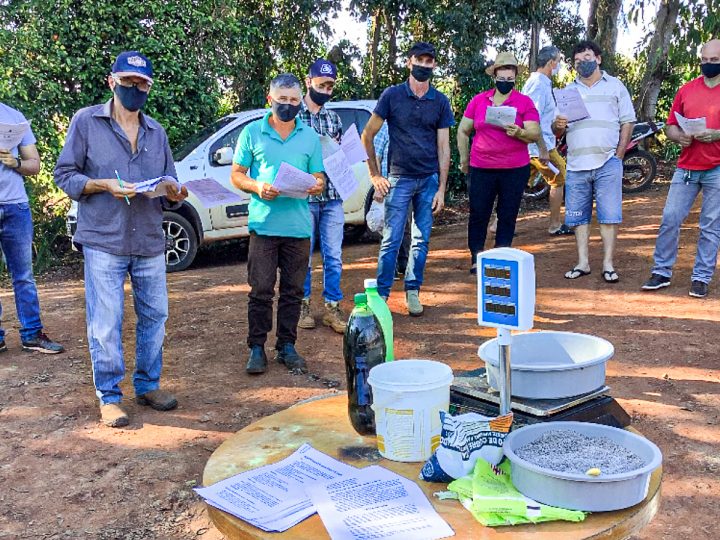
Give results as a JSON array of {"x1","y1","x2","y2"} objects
[{"x1": 463, "y1": 88, "x2": 540, "y2": 169}]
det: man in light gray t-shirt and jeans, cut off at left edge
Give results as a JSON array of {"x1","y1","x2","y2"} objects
[{"x1": 0, "y1": 103, "x2": 64, "y2": 354}]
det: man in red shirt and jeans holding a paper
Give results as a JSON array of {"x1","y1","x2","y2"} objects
[{"x1": 642, "y1": 39, "x2": 720, "y2": 298}]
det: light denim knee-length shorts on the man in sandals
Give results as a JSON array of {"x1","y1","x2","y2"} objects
[{"x1": 565, "y1": 156, "x2": 623, "y2": 227}]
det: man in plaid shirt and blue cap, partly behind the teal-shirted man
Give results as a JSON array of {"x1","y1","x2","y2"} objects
[{"x1": 298, "y1": 58, "x2": 346, "y2": 333}]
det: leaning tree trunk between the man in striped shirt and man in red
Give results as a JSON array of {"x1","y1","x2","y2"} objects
[{"x1": 635, "y1": 0, "x2": 680, "y2": 121}]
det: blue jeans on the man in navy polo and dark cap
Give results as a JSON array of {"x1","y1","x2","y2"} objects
[{"x1": 377, "y1": 174, "x2": 438, "y2": 296}]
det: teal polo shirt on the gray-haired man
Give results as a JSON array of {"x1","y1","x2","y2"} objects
[{"x1": 233, "y1": 111, "x2": 325, "y2": 238}]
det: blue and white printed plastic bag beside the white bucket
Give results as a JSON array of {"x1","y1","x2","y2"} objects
[{"x1": 420, "y1": 411, "x2": 513, "y2": 482}]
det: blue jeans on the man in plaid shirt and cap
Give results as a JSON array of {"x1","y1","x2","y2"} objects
[{"x1": 305, "y1": 199, "x2": 345, "y2": 302}]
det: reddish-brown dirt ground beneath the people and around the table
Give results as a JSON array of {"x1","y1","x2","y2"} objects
[{"x1": 0, "y1": 174, "x2": 720, "y2": 540}]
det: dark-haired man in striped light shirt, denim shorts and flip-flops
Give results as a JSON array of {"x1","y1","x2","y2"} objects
[{"x1": 553, "y1": 41, "x2": 635, "y2": 283}]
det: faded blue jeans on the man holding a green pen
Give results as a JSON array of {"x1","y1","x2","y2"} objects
[{"x1": 83, "y1": 247, "x2": 168, "y2": 405}]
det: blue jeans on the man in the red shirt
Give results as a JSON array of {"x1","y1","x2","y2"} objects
[{"x1": 652, "y1": 166, "x2": 720, "y2": 283}]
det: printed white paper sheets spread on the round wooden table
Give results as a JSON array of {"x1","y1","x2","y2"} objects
[{"x1": 195, "y1": 444, "x2": 455, "y2": 540}]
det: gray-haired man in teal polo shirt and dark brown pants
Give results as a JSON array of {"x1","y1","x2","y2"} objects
[{"x1": 231, "y1": 74, "x2": 325, "y2": 374}]
